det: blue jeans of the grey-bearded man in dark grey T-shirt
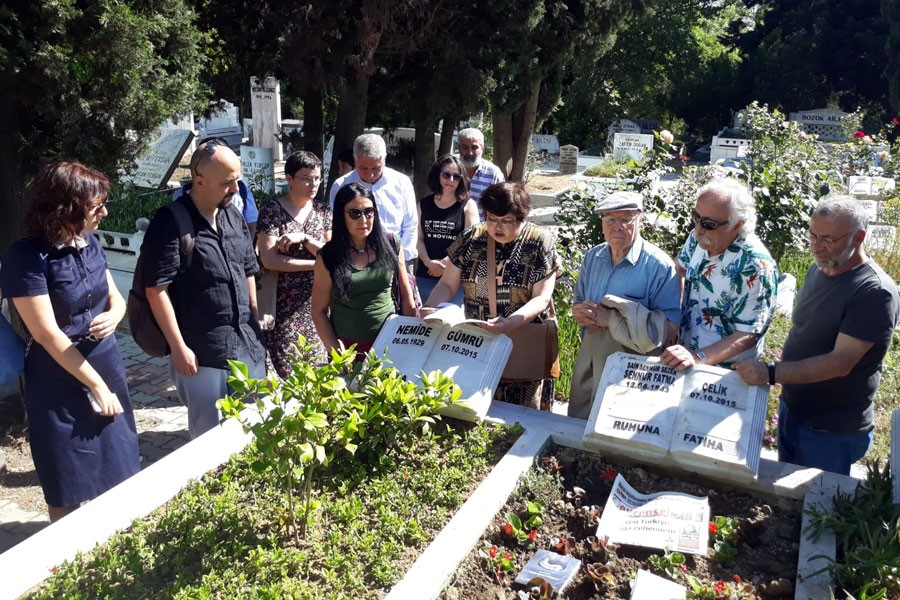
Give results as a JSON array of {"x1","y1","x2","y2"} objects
[{"x1": 778, "y1": 401, "x2": 875, "y2": 475}]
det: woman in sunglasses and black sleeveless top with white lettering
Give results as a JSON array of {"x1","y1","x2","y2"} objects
[{"x1": 416, "y1": 154, "x2": 478, "y2": 305}]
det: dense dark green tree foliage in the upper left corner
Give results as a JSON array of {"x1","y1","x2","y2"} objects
[{"x1": 0, "y1": 0, "x2": 203, "y2": 251}]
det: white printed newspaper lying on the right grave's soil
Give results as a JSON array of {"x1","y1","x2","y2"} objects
[{"x1": 597, "y1": 474, "x2": 709, "y2": 554}]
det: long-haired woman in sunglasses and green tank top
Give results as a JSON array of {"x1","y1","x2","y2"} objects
[{"x1": 312, "y1": 183, "x2": 416, "y2": 357}]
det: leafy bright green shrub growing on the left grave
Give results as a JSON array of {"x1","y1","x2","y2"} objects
[{"x1": 216, "y1": 337, "x2": 460, "y2": 541}]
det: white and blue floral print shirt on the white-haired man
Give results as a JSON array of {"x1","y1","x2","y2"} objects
[{"x1": 678, "y1": 231, "x2": 779, "y2": 366}]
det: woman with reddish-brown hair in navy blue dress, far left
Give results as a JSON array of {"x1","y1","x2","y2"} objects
[{"x1": 0, "y1": 162, "x2": 140, "y2": 521}]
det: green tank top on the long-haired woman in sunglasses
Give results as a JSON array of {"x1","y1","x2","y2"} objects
[{"x1": 331, "y1": 266, "x2": 394, "y2": 341}]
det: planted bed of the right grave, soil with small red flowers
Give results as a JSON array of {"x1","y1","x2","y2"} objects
[{"x1": 442, "y1": 446, "x2": 801, "y2": 600}]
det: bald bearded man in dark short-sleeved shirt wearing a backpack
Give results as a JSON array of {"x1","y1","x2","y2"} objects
[{"x1": 141, "y1": 141, "x2": 266, "y2": 438}]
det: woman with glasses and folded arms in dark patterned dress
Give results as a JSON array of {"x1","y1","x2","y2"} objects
[{"x1": 256, "y1": 151, "x2": 332, "y2": 377}]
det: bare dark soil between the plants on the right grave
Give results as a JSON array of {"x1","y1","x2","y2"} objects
[{"x1": 441, "y1": 446, "x2": 802, "y2": 600}]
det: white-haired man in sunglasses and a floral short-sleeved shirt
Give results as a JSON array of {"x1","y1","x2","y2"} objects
[{"x1": 660, "y1": 178, "x2": 778, "y2": 371}]
